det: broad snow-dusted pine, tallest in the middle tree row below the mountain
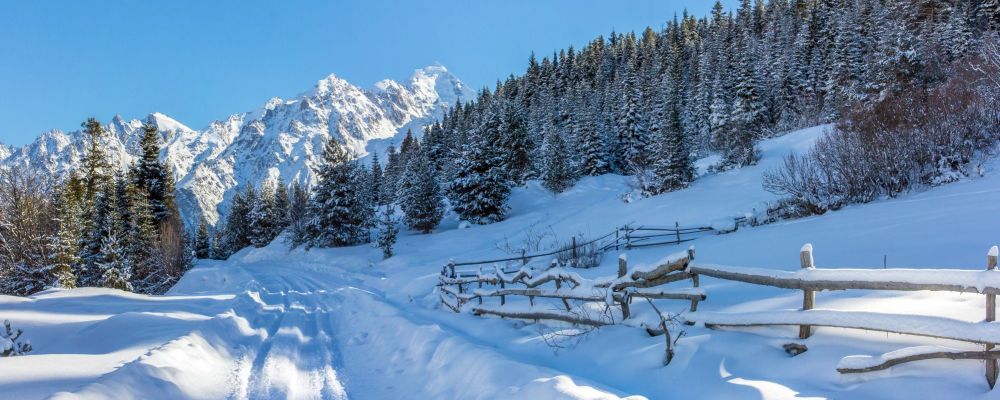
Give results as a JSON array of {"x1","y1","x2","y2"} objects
[{"x1": 308, "y1": 138, "x2": 373, "y2": 247}]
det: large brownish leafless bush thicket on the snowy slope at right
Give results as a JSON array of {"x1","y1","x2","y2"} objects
[{"x1": 763, "y1": 43, "x2": 1000, "y2": 215}]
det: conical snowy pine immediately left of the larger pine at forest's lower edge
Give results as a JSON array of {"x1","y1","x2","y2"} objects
[{"x1": 399, "y1": 150, "x2": 444, "y2": 233}]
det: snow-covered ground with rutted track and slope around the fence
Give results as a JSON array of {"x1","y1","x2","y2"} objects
[{"x1": 0, "y1": 127, "x2": 1000, "y2": 399}]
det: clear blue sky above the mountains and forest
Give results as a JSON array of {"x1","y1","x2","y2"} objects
[{"x1": 0, "y1": 0, "x2": 736, "y2": 145}]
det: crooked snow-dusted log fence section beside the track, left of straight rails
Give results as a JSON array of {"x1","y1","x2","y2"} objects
[{"x1": 438, "y1": 248, "x2": 706, "y2": 363}]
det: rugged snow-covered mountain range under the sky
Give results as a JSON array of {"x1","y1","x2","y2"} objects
[{"x1": 0, "y1": 65, "x2": 474, "y2": 226}]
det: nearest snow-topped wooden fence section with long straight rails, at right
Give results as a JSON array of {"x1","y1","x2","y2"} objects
[{"x1": 685, "y1": 244, "x2": 1000, "y2": 389}]
